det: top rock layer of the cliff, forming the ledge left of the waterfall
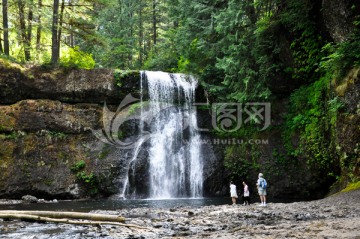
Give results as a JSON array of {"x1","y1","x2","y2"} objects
[{"x1": 0, "y1": 63, "x2": 139, "y2": 104}]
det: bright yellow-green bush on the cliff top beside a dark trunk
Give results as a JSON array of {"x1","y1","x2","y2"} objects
[{"x1": 60, "y1": 47, "x2": 95, "y2": 70}]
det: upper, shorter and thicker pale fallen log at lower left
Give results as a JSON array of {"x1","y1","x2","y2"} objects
[{"x1": 0, "y1": 210, "x2": 125, "y2": 222}]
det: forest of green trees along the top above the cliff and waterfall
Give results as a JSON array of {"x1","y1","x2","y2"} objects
[{"x1": 0, "y1": 0, "x2": 360, "y2": 102}]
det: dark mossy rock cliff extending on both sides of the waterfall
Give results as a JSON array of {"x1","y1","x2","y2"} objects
[{"x1": 0, "y1": 61, "x2": 360, "y2": 199}]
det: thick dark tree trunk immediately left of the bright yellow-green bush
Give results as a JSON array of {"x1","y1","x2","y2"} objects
[{"x1": 51, "y1": 0, "x2": 60, "y2": 65}]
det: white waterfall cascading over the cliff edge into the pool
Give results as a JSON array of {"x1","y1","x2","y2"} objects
[{"x1": 139, "y1": 71, "x2": 203, "y2": 198}]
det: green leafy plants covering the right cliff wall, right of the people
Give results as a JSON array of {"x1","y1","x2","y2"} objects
[{"x1": 284, "y1": 77, "x2": 342, "y2": 176}]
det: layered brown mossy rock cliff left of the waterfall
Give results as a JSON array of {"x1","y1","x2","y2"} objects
[{"x1": 0, "y1": 62, "x2": 228, "y2": 199}]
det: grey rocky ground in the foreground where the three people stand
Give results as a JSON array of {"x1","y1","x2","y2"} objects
[{"x1": 0, "y1": 190, "x2": 360, "y2": 239}]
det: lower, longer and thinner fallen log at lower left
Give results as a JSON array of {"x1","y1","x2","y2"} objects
[{"x1": 0, "y1": 211, "x2": 153, "y2": 231}]
